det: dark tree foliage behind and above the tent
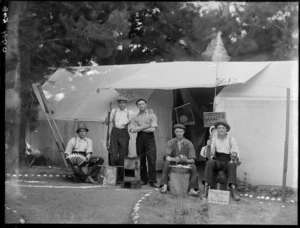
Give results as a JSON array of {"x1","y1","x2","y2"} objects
[{"x1": 6, "y1": 1, "x2": 298, "y2": 162}]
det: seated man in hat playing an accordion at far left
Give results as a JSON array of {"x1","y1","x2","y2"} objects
[{"x1": 64, "y1": 123, "x2": 104, "y2": 184}]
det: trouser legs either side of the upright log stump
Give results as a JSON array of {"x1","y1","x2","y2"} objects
[{"x1": 160, "y1": 161, "x2": 199, "y2": 189}]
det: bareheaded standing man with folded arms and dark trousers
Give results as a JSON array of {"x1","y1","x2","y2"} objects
[{"x1": 130, "y1": 98, "x2": 158, "y2": 188}]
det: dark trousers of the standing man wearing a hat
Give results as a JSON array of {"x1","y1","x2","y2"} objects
[{"x1": 110, "y1": 127, "x2": 130, "y2": 181}]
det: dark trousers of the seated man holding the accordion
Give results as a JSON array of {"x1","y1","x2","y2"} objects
[{"x1": 71, "y1": 155, "x2": 104, "y2": 181}]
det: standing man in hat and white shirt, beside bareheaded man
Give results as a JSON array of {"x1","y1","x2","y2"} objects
[{"x1": 104, "y1": 96, "x2": 134, "y2": 184}]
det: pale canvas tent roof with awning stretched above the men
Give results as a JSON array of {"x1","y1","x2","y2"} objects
[{"x1": 42, "y1": 62, "x2": 296, "y2": 120}]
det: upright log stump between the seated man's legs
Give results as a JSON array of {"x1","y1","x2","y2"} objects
[{"x1": 170, "y1": 166, "x2": 190, "y2": 196}]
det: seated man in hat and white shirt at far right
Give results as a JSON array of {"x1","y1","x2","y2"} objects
[{"x1": 201, "y1": 119, "x2": 240, "y2": 201}]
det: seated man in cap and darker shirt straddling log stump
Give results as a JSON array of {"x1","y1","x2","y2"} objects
[{"x1": 160, "y1": 124, "x2": 199, "y2": 196}]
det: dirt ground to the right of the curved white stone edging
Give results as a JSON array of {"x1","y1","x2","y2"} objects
[{"x1": 139, "y1": 188, "x2": 298, "y2": 225}]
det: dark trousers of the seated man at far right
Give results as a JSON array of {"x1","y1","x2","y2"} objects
[{"x1": 202, "y1": 152, "x2": 236, "y2": 187}]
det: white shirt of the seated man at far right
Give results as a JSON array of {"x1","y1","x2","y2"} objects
[{"x1": 200, "y1": 135, "x2": 240, "y2": 159}]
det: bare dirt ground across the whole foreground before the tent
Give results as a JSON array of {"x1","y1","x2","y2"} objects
[{"x1": 5, "y1": 167, "x2": 298, "y2": 225}]
